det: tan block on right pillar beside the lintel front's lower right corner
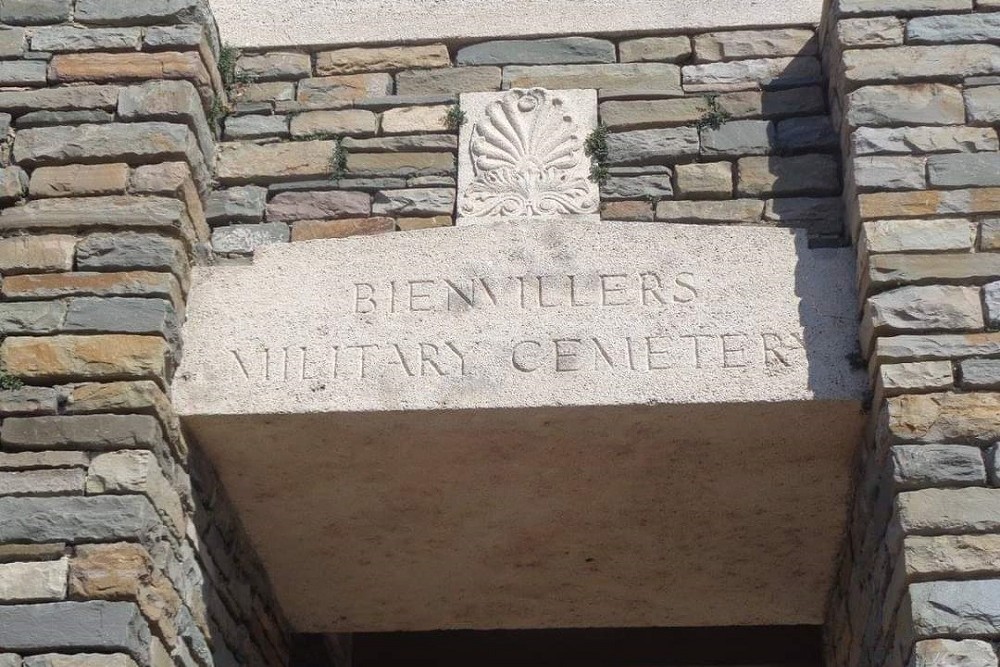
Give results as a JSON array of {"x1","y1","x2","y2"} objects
[{"x1": 881, "y1": 392, "x2": 1000, "y2": 444}]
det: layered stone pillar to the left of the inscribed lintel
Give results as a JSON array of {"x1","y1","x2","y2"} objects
[{"x1": 0, "y1": 0, "x2": 287, "y2": 667}]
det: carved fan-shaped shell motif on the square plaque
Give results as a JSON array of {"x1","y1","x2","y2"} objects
[{"x1": 460, "y1": 88, "x2": 598, "y2": 217}]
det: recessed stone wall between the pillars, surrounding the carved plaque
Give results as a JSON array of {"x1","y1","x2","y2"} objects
[{"x1": 213, "y1": 27, "x2": 842, "y2": 256}]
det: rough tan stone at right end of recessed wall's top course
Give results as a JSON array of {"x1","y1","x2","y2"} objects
[{"x1": 694, "y1": 28, "x2": 818, "y2": 62}]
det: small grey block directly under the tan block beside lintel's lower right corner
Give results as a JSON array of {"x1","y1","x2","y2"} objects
[{"x1": 891, "y1": 445, "x2": 986, "y2": 490}]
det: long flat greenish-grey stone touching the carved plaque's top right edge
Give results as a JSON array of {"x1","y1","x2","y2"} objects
[{"x1": 503, "y1": 63, "x2": 682, "y2": 95}]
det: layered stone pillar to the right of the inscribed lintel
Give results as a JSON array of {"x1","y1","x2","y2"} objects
[{"x1": 825, "y1": 0, "x2": 1000, "y2": 667}]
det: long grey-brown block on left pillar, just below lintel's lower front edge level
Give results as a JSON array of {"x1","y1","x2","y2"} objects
[{"x1": 0, "y1": 415, "x2": 163, "y2": 451}]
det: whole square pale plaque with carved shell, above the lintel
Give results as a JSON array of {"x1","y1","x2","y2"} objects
[{"x1": 458, "y1": 88, "x2": 600, "y2": 225}]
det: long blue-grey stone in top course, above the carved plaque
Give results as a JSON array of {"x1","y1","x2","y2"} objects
[{"x1": 455, "y1": 37, "x2": 615, "y2": 65}]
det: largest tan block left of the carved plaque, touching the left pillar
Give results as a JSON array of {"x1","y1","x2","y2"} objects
[{"x1": 217, "y1": 141, "x2": 337, "y2": 185}]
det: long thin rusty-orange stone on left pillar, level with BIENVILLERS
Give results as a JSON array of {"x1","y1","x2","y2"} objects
[{"x1": 0, "y1": 271, "x2": 184, "y2": 312}]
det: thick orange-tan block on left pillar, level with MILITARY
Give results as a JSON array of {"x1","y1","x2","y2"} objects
[{"x1": 0, "y1": 334, "x2": 170, "y2": 382}]
